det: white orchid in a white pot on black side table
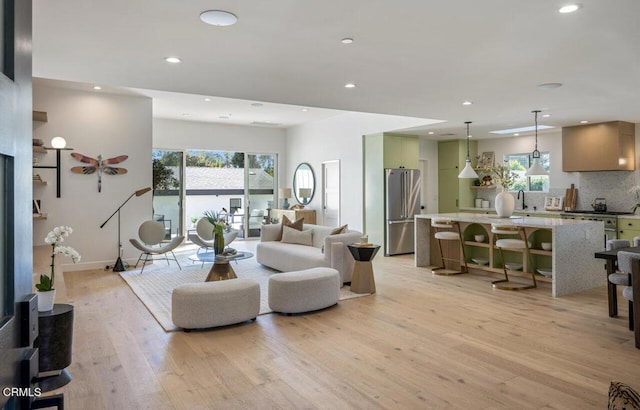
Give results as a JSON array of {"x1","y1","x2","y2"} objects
[{"x1": 36, "y1": 226, "x2": 80, "y2": 312}]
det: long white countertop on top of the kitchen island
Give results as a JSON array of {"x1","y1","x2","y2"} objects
[{"x1": 415, "y1": 212, "x2": 603, "y2": 229}]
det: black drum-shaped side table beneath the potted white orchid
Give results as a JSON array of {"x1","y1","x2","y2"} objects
[{"x1": 33, "y1": 304, "x2": 73, "y2": 392}]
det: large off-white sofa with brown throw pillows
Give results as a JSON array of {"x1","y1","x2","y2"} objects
[{"x1": 256, "y1": 224, "x2": 362, "y2": 283}]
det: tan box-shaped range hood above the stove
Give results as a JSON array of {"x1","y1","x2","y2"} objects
[{"x1": 562, "y1": 121, "x2": 636, "y2": 172}]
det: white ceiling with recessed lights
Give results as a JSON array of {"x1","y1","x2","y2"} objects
[{"x1": 33, "y1": 0, "x2": 640, "y2": 139}]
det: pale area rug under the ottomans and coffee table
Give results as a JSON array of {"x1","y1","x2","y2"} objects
[{"x1": 120, "y1": 255, "x2": 370, "y2": 332}]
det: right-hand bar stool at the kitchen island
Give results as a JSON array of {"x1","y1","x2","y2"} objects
[{"x1": 491, "y1": 224, "x2": 538, "y2": 290}]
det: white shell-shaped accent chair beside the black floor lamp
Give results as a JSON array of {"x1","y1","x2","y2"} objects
[{"x1": 129, "y1": 221, "x2": 184, "y2": 273}]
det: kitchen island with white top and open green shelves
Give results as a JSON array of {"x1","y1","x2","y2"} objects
[{"x1": 414, "y1": 213, "x2": 607, "y2": 297}]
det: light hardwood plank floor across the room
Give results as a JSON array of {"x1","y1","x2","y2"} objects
[{"x1": 42, "y1": 245, "x2": 640, "y2": 409}]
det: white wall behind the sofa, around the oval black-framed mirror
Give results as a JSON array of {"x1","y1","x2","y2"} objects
[{"x1": 283, "y1": 112, "x2": 424, "y2": 231}]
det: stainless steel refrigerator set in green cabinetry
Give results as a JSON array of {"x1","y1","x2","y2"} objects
[{"x1": 385, "y1": 169, "x2": 422, "y2": 255}]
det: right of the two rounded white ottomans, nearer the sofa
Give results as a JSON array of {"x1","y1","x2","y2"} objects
[{"x1": 269, "y1": 268, "x2": 340, "y2": 313}]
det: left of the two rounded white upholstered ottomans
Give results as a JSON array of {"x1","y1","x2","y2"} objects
[{"x1": 171, "y1": 279, "x2": 260, "y2": 331}]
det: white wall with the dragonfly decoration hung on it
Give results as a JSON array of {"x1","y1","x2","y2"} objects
[{"x1": 33, "y1": 80, "x2": 152, "y2": 270}]
